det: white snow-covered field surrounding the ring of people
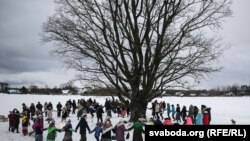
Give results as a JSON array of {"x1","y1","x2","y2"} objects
[{"x1": 0, "y1": 94, "x2": 250, "y2": 141}]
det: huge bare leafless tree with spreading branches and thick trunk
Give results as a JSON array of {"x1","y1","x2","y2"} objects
[{"x1": 43, "y1": 0, "x2": 232, "y2": 124}]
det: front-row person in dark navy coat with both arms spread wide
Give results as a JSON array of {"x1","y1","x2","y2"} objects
[{"x1": 75, "y1": 114, "x2": 90, "y2": 141}]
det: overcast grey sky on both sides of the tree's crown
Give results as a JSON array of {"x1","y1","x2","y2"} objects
[{"x1": 0, "y1": 0, "x2": 250, "y2": 89}]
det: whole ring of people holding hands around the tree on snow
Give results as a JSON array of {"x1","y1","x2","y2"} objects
[{"x1": 8, "y1": 98, "x2": 211, "y2": 141}]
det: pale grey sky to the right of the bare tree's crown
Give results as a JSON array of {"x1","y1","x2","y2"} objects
[{"x1": 200, "y1": 0, "x2": 250, "y2": 88}]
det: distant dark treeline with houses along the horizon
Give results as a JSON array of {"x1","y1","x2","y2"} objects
[{"x1": 0, "y1": 85, "x2": 250, "y2": 96}]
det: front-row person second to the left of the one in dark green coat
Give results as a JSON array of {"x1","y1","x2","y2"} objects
[{"x1": 101, "y1": 117, "x2": 113, "y2": 141}]
